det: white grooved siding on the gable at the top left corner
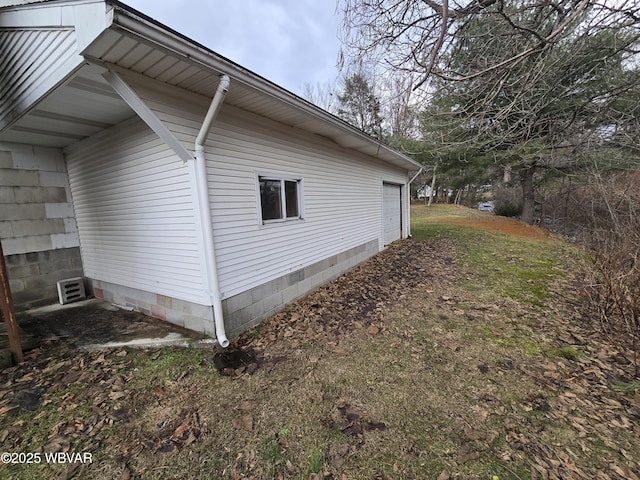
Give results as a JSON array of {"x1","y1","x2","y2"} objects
[{"x1": 0, "y1": 29, "x2": 81, "y2": 129}]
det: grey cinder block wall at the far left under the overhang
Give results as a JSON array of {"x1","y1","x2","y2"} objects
[{"x1": 0, "y1": 143, "x2": 83, "y2": 310}]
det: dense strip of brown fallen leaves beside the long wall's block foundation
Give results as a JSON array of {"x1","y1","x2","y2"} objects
[{"x1": 236, "y1": 240, "x2": 456, "y2": 355}]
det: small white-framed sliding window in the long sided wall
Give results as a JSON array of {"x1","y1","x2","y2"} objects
[{"x1": 258, "y1": 175, "x2": 302, "y2": 223}]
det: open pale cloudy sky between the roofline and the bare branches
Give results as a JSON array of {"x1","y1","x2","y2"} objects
[{"x1": 123, "y1": 0, "x2": 340, "y2": 95}]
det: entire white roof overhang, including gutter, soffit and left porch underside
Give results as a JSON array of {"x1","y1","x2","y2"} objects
[{"x1": 0, "y1": 0, "x2": 421, "y2": 171}]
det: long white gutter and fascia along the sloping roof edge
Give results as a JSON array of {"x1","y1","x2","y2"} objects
[{"x1": 102, "y1": 6, "x2": 422, "y2": 171}]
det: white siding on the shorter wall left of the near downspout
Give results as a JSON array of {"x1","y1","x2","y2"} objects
[{"x1": 67, "y1": 116, "x2": 203, "y2": 303}]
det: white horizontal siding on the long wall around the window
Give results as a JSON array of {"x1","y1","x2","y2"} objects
[{"x1": 114, "y1": 73, "x2": 406, "y2": 298}]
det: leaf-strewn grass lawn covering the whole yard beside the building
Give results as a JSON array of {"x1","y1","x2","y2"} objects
[{"x1": 0, "y1": 205, "x2": 640, "y2": 480}]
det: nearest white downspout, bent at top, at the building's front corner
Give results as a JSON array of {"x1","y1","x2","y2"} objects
[{"x1": 194, "y1": 75, "x2": 230, "y2": 348}]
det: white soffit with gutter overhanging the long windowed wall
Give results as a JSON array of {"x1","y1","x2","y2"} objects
[{"x1": 85, "y1": 4, "x2": 421, "y2": 170}]
